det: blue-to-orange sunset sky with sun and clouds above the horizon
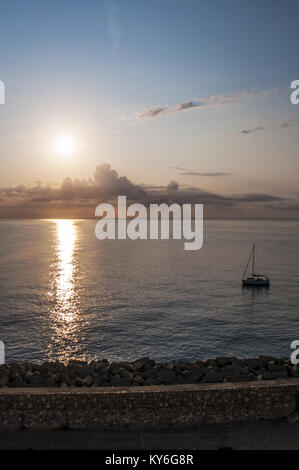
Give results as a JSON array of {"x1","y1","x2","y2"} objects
[{"x1": 0, "y1": 0, "x2": 299, "y2": 218}]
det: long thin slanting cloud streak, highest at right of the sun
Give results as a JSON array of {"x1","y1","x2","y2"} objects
[{"x1": 138, "y1": 88, "x2": 277, "y2": 119}]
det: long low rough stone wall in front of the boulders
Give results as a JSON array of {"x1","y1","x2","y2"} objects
[{"x1": 0, "y1": 379, "x2": 299, "y2": 429}]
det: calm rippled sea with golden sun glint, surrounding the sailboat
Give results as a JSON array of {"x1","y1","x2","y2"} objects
[{"x1": 0, "y1": 220, "x2": 299, "y2": 361}]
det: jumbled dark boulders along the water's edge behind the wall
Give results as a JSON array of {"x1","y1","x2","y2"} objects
[{"x1": 0, "y1": 356, "x2": 299, "y2": 387}]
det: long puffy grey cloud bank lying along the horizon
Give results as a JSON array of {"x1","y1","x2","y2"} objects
[{"x1": 0, "y1": 163, "x2": 299, "y2": 218}]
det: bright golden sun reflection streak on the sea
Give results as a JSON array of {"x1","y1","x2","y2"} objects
[{"x1": 48, "y1": 220, "x2": 82, "y2": 361}]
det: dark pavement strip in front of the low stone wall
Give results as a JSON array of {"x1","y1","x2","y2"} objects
[{"x1": 0, "y1": 422, "x2": 299, "y2": 450}]
